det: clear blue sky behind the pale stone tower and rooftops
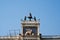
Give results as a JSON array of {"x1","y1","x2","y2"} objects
[{"x1": 0, "y1": 0, "x2": 60, "y2": 36}]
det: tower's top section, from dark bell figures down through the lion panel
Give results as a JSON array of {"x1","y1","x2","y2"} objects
[{"x1": 21, "y1": 13, "x2": 40, "y2": 36}]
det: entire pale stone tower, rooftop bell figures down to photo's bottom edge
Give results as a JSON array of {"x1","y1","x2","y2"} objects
[{"x1": 21, "y1": 13, "x2": 40, "y2": 40}]
